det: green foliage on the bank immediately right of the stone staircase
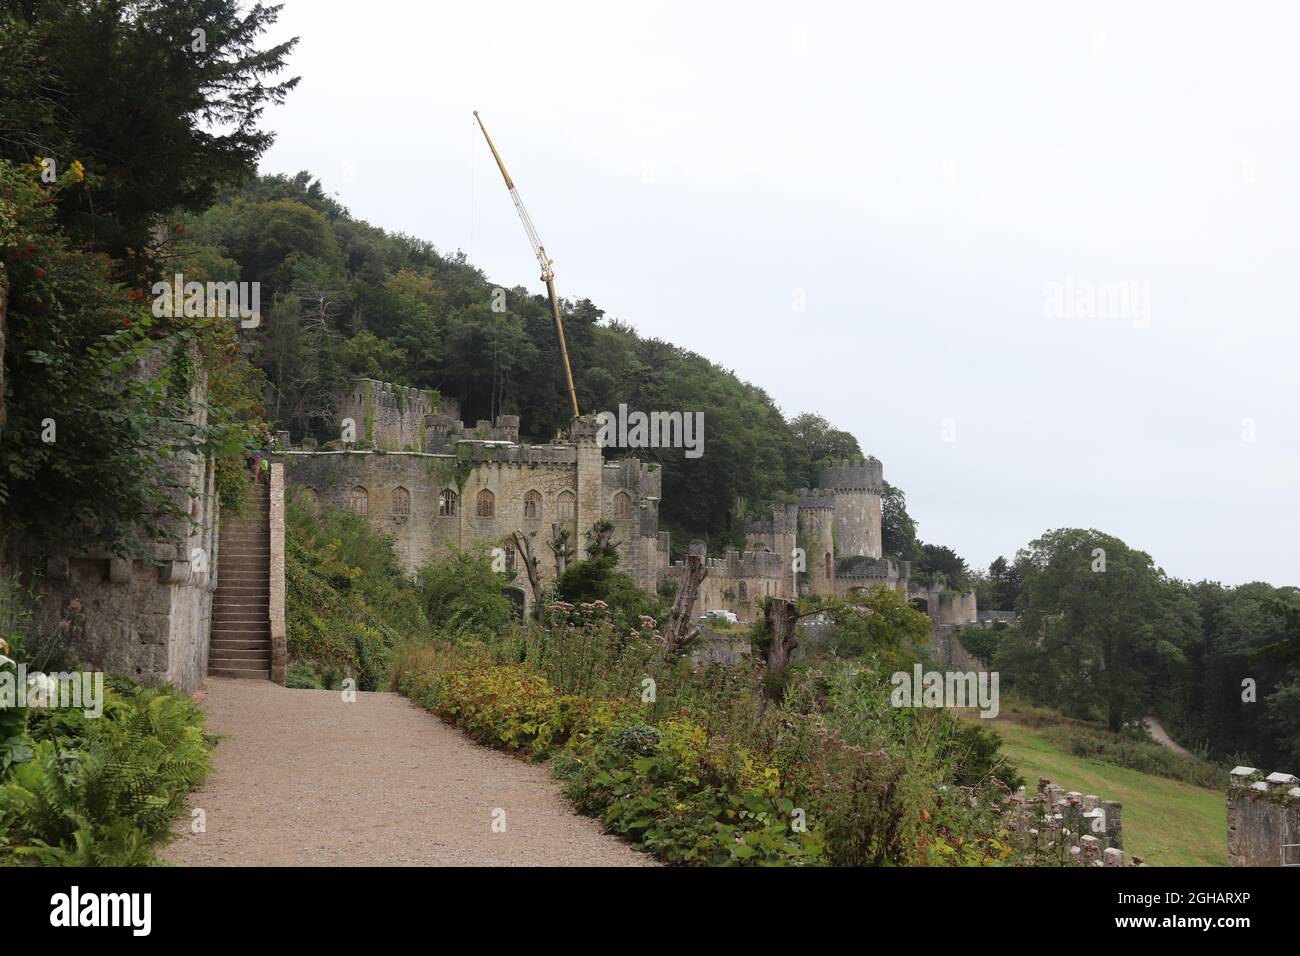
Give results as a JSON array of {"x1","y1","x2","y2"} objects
[{"x1": 285, "y1": 488, "x2": 429, "y2": 691}]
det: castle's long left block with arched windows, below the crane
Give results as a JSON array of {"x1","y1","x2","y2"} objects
[{"x1": 281, "y1": 382, "x2": 668, "y2": 601}]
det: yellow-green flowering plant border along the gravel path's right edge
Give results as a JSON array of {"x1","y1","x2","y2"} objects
[{"x1": 393, "y1": 605, "x2": 1045, "y2": 866}]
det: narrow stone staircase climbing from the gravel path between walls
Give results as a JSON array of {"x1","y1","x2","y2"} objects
[{"x1": 208, "y1": 483, "x2": 270, "y2": 680}]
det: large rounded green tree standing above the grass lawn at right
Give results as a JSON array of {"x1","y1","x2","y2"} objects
[{"x1": 1013, "y1": 528, "x2": 1200, "y2": 732}]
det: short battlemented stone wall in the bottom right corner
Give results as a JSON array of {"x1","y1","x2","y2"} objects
[{"x1": 1227, "y1": 767, "x2": 1300, "y2": 866}]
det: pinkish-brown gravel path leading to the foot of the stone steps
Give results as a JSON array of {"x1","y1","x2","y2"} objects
[{"x1": 161, "y1": 678, "x2": 655, "y2": 866}]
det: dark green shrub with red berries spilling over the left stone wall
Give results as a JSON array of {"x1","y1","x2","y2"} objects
[{"x1": 0, "y1": 161, "x2": 254, "y2": 553}]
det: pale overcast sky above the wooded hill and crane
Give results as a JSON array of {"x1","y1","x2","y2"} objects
[{"x1": 253, "y1": 0, "x2": 1300, "y2": 584}]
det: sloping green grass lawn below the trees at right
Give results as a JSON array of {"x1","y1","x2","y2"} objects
[{"x1": 995, "y1": 718, "x2": 1227, "y2": 866}]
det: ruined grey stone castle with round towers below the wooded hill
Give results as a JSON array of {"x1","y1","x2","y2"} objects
[{"x1": 281, "y1": 378, "x2": 975, "y2": 626}]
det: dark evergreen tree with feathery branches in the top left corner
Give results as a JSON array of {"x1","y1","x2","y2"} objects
[{"x1": 0, "y1": 0, "x2": 298, "y2": 274}]
